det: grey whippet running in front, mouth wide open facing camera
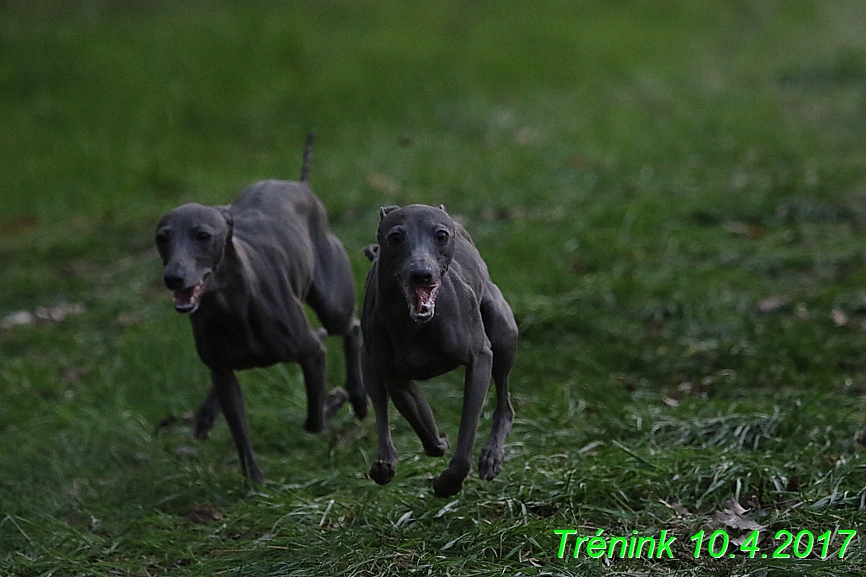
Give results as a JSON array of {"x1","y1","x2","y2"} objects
[{"x1": 361, "y1": 205, "x2": 517, "y2": 497}]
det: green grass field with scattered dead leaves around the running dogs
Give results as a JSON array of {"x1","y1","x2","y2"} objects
[{"x1": 0, "y1": 0, "x2": 866, "y2": 577}]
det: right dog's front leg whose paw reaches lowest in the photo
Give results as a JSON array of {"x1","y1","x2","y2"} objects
[{"x1": 433, "y1": 347, "x2": 493, "y2": 497}]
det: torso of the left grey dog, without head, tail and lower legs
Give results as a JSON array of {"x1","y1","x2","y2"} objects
[{"x1": 190, "y1": 187, "x2": 354, "y2": 369}]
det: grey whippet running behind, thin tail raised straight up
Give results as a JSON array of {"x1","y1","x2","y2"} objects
[{"x1": 156, "y1": 135, "x2": 367, "y2": 484}]
